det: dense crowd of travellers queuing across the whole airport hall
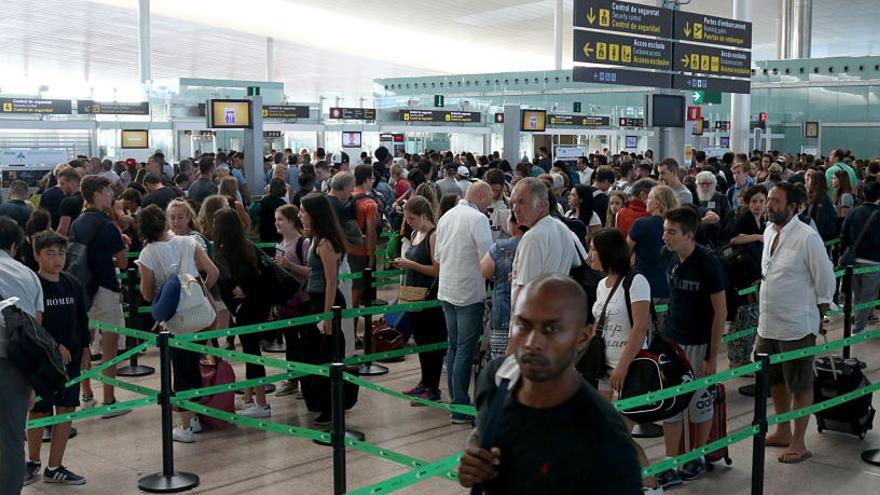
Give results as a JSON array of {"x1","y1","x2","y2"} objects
[{"x1": 0, "y1": 141, "x2": 880, "y2": 493}]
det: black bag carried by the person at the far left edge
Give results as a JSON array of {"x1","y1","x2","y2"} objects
[{"x1": 0, "y1": 298, "x2": 69, "y2": 397}]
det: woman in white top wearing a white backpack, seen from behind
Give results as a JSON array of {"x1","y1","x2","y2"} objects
[{"x1": 136, "y1": 205, "x2": 220, "y2": 443}]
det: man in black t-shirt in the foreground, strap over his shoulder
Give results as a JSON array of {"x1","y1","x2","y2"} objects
[{"x1": 459, "y1": 274, "x2": 642, "y2": 495}]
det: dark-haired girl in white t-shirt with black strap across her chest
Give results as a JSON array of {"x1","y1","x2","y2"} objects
[{"x1": 590, "y1": 228, "x2": 659, "y2": 493}]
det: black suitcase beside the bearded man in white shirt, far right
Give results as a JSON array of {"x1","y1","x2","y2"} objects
[{"x1": 813, "y1": 356, "x2": 876, "y2": 439}]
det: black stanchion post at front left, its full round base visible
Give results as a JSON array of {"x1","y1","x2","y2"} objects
[{"x1": 138, "y1": 330, "x2": 199, "y2": 493}]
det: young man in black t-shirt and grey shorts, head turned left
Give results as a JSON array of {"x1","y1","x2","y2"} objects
[{"x1": 657, "y1": 207, "x2": 727, "y2": 488}]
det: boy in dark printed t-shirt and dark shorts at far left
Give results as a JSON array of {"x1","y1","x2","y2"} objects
[{"x1": 25, "y1": 230, "x2": 89, "y2": 485}]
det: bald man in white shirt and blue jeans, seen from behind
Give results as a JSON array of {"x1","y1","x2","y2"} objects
[{"x1": 434, "y1": 181, "x2": 492, "y2": 424}]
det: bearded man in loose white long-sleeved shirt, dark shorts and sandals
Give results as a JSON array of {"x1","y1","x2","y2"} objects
[{"x1": 756, "y1": 182, "x2": 835, "y2": 464}]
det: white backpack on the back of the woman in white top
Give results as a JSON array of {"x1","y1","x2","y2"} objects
[{"x1": 156, "y1": 240, "x2": 217, "y2": 334}]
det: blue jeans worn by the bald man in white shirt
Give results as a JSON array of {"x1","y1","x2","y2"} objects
[{"x1": 443, "y1": 301, "x2": 485, "y2": 416}]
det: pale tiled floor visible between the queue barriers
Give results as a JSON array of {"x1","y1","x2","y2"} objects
[{"x1": 23, "y1": 316, "x2": 880, "y2": 495}]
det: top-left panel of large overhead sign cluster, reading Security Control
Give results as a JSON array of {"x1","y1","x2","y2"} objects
[{"x1": 574, "y1": 0, "x2": 672, "y2": 38}]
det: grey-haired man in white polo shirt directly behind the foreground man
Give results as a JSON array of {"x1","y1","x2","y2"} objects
[{"x1": 510, "y1": 177, "x2": 587, "y2": 304}]
